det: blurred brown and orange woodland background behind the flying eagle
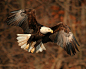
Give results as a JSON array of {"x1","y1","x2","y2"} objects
[{"x1": 0, "y1": 0, "x2": 86, "y2": 69}]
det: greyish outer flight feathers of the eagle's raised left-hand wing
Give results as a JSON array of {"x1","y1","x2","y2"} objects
[{"x1": 6, "y1": 10, "x2": 28, "y2": 31}]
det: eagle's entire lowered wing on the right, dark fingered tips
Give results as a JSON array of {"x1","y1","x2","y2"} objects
[{"x1": 50, "y1": 23, "x2": 79, "y2": 55}]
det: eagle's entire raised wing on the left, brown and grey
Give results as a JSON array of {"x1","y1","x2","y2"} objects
[{"x1": 6, "y1": 9, "x2": 42, "y2": 33}]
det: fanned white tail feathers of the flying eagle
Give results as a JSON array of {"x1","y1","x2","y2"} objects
[{"x1": 17, "y1": 34, "x2": 46, "y2": 53}]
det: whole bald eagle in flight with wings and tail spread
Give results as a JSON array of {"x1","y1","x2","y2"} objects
[{"x1": 6, "y1": 9, "x2": 80, "y2": 55}]
